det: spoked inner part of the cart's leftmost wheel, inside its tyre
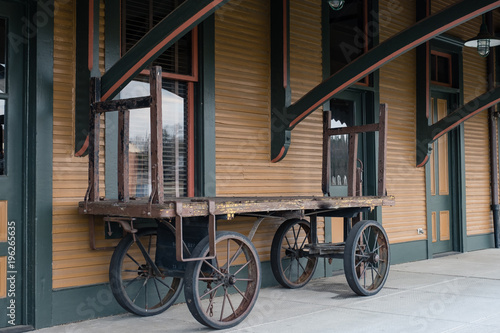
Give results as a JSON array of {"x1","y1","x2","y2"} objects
[{"x1": 119, "y1": 233, "x2": 181, "y2": 315}]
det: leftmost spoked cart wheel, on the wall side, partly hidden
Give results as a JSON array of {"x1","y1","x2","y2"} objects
[{"x1": 109, "y1": 228, "x2": 182, "y2": 316}]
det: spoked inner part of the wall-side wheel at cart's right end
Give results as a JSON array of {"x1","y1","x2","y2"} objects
[{"x1": 279, "y1": 222, "x2": 317, "y2": 286}]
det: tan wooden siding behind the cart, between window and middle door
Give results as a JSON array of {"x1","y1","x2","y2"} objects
[{"x1": 215, "y1": 0, "x2": 324, "y2": 249}]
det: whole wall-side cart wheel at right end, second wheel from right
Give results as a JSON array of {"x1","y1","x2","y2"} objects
[{"x1": 271, "y1": 219, "x2": 318, "y2": 288}]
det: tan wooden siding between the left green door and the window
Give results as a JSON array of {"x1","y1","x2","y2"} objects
[{"x1": 52, "y1": 1, "x2": 114, "y2": 289}]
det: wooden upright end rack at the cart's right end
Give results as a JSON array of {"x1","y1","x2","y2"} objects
[{"x1": 321, "y1": 104, "x2": 387, "y2": 196}]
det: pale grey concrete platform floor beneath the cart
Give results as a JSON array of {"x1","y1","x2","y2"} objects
[{"x1": 37, "y1": 249, "x2": 500, "y2": 333}]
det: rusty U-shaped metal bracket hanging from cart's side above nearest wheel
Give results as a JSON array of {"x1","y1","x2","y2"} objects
[{"x1": 175, "y1": 200, "x2": 216, "y2": 262}]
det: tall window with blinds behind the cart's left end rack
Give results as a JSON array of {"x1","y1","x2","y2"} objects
[{"x1": 121, "y1": 0, "x2": 198, "y2": 197}]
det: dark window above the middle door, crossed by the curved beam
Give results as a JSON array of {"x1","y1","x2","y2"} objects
[{"x1": 329, "y1": 0, "x2": 372, "y2": 86}]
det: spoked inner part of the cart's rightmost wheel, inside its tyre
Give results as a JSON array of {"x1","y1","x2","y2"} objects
[{"x1": 353, "y1": 224, "x2": 389, "y2": 292}]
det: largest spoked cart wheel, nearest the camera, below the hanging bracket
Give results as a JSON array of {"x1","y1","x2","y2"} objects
[{"x1": 184, "y1": 232, "x2": 261, "y2": 329}]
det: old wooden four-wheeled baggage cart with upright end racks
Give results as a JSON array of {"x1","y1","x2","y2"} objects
[{"x1": 79, "y1": 67, "x2": 394, "y2": 329}]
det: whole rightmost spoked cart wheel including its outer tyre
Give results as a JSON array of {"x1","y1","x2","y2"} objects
[{"x1": 344, "y1": 221, "x2": 390, "y2": 296}]
